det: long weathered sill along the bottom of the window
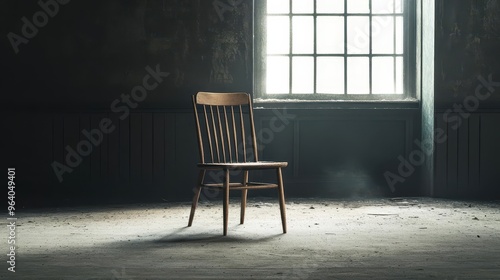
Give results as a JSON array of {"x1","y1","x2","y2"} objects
[{"x1": 253, "y1": 98, "x2": 420, "y2": 109}]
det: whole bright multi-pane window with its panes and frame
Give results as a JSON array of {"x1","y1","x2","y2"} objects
[{"x1": 255, "y1": 0, "x2": 416, "y2": 100}]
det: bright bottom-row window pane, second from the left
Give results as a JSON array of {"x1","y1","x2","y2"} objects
[{"x1": 292, "y1": 57, "x2": 314, "y2": 93}]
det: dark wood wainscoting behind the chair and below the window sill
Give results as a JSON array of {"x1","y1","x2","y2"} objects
[{"x1": 1, "y1": 109, "x2": 422, "y2": 206}]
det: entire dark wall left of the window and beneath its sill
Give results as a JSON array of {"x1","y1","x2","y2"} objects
[{"x1": 0, "y1": 0, "x2": 420, "y2": 206}]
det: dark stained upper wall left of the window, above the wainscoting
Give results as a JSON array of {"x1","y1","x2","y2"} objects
[{"x1": 0, "y1": 0, "x2": 252, "y2": 110}]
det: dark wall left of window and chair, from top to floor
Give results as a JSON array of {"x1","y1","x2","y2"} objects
[{"x1": 0, "y1": 0, "x2": 252, "y2": 206}]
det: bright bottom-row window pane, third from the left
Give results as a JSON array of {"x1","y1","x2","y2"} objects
[{"x1": 316, "y1": 57, "x2": 344, "y2": 94}]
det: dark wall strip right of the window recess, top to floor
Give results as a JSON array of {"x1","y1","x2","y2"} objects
[{"x1": 435, "y1": 0, "x2": 500, "y2": 198}]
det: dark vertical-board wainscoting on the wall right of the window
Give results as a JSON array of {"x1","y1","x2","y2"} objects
[{"x1": 434, "y1": 112, "x2": 500, "y2": 199}]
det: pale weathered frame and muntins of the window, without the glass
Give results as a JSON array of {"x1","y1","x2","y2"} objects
[{"x1": 253, "y1": 0, "x2": 418, "y2": 103}]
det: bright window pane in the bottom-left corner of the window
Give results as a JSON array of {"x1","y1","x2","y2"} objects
[{"x1": 266, "y1": 56, "x2": 290, "y2": 93}]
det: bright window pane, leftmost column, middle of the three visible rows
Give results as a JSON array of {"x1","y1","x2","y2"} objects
[{"x1": 267, "y1": 16, "x2": 290, "y2": 54}]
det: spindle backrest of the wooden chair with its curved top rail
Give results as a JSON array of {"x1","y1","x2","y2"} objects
[{"x1": 193, "y1": 92, "x2": 259, "y2": 163}]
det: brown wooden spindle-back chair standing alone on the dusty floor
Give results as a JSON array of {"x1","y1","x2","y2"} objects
[{"x1": 188, "y1": 92, "x2": 288, "y2": 235}]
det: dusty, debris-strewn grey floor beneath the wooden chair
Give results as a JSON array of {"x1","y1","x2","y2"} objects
[{"x1": 0, "y1": 198, "x2": 500, "y2": 280}]
